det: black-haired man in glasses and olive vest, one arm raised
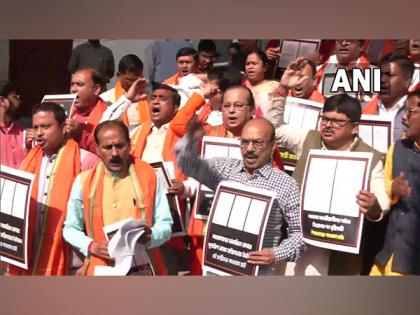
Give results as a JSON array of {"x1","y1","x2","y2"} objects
[{"x1": 268, "y1": 58, "x2": 390, "y2": 275}]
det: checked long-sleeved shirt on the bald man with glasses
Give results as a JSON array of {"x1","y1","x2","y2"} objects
[{"x1": 175, "y1": 137, "x2": 304, "y2": 262}]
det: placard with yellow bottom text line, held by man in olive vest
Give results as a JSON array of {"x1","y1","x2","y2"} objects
[{"x1": 300, "y1": 150, "x2": 372, "y2": 254}]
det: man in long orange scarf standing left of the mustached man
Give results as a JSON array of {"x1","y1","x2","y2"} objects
[{"x1": 8, "y1": 103, "x2": 98, "y2": 276}]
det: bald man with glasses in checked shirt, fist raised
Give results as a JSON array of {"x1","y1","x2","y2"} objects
[{"x1": 175, "y1": 118, "x2": 303, "y2": 274}]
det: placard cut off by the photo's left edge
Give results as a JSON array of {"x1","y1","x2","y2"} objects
[{"x1": 0, "y1": 165, "x2": 35, "y2": 269}]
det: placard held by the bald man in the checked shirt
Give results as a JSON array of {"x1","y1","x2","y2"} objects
[{"x1": 203, "y1": 182, "x2": 275, "y2": 276}]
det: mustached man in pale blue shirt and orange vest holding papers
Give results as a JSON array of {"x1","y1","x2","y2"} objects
[{"x1": 63, "y1": 121, "x2": 173, "y2": 275}]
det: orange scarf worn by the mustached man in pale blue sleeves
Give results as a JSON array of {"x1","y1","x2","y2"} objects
[{"x1": 82, "y1": 159, "x2": 167, "y2": 275}]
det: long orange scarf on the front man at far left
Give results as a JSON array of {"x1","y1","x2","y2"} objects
[{"x1": 9, "y1": 139, "x2": 80, "y2": 276}]
